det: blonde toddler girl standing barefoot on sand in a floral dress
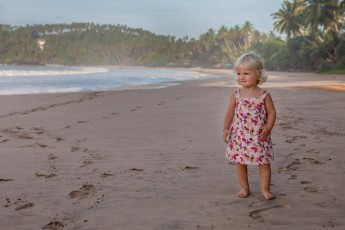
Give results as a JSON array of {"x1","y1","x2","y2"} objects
[{"x1": 223, "y1": 53, "x2": 276, "y2": 200}]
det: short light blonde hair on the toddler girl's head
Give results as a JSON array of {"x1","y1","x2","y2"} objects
[{"x1": 234, "y1": 53, "x2": 268, "y2": 85}]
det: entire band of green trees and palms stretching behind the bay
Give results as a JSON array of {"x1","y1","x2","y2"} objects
[{"x1": 0, "y1": 0, "x2": 345, "y2": 73}]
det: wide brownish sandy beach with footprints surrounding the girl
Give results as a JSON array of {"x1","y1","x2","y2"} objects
[{"x1": 0, "y1": 69, "x2": 345, "y2": 230}]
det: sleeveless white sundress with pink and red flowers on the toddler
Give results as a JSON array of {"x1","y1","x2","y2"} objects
[{"x1": 225, "y1": 89, "x2": 274, "y2": 165}]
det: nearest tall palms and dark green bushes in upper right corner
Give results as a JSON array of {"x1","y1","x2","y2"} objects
[{"x1": 272, "y1": 0, "x2": 345, "y2": 72}]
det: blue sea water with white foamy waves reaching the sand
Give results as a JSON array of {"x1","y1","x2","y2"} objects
[{"x1": 0, "y1": 65, "x2": 211, "y2": 95}]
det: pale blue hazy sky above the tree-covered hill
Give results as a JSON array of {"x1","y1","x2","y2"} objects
[{"x1": 0, "y1": 0, "x2": 284, "y2": 38}]
